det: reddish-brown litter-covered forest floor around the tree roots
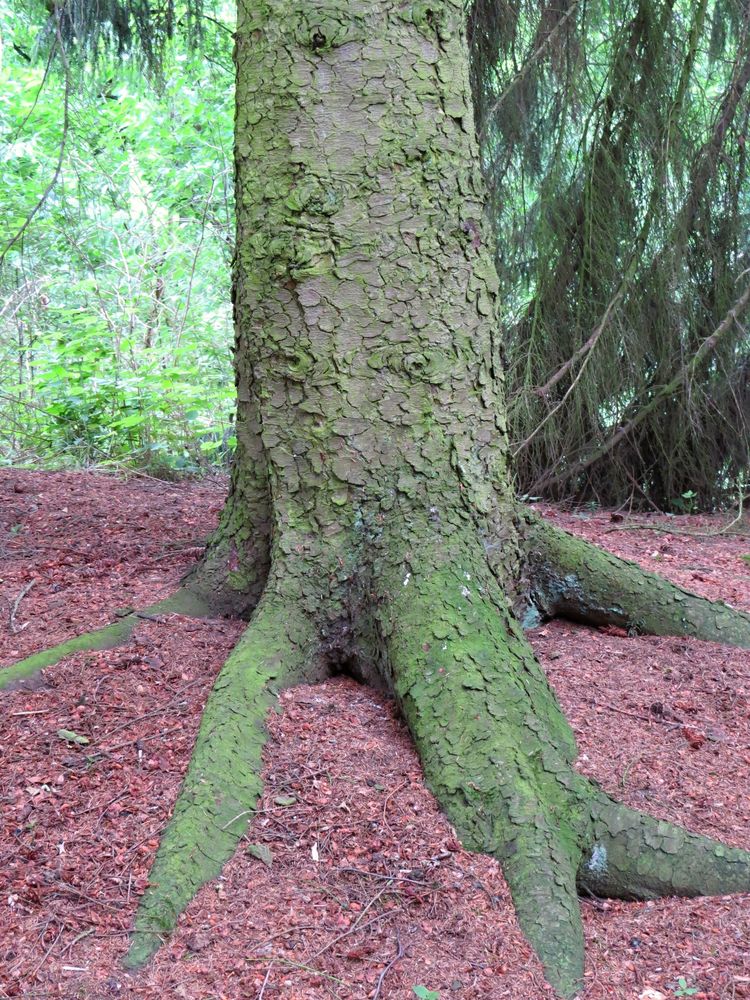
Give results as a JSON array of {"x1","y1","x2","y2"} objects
[{"x1": 0, "y1": 470, "x2": 750, "y2": 1000}]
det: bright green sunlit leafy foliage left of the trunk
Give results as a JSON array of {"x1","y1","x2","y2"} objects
[{"x1": 0, "y1": 0, "x2": 234, "y2": 469}]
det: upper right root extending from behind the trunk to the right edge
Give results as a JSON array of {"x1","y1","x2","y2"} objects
[{"x1": 526, "y1": 514, "x2": 750, "y2": 648}]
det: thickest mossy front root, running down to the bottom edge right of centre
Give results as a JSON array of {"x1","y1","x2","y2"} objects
[{"x1": 380, "y1": 538, "x2": 589, "y2": 997}]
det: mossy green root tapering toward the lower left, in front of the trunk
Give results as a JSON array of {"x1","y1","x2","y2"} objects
[{"x1": 125, "y1": 589, "x2": 322, "y2": 968}]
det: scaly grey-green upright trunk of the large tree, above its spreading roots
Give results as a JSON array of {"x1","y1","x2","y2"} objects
[{"x1": 217, "y1": 0, "x2": 524, "y2": 576}]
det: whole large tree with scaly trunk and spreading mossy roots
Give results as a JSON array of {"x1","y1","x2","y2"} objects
[{"x1": 4, "y1": 0, "x2": 750, "y2": 997}]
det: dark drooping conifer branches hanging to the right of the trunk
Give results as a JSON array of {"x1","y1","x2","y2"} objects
[{"x1": 469, "y1": 0, "x2": 750, "y2": 509}]
